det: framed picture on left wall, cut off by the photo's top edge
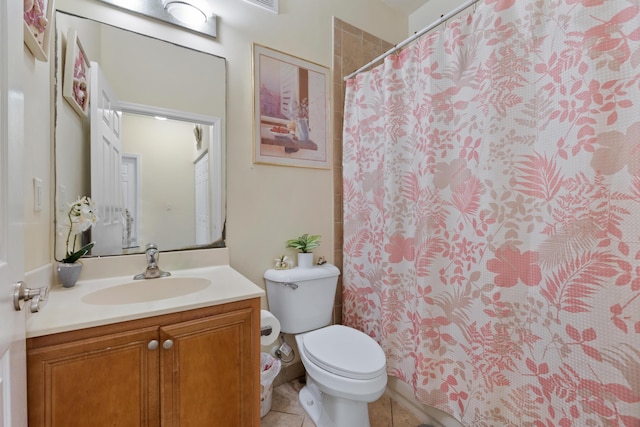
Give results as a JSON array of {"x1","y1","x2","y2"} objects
[{"x1": 23, "y1": 0, "x2": 53, "y2": 62}]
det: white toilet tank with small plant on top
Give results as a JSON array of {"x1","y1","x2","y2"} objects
[{"x1": 264, "y1": 264, "x2": 340, "y2": 334}]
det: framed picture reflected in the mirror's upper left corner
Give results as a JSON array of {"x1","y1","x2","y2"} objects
[{"x1": 62, "y1": 28, "x2": 90, "y2": 116}]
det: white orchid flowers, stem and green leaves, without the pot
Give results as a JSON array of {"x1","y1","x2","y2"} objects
[{"x1": 62, "y1": 196, "x2": 98, "y2": 263}]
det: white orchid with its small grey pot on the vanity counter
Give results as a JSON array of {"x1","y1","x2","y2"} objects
[{"x1": 57, "y1": 196, "x2": 98, "y2": 288}]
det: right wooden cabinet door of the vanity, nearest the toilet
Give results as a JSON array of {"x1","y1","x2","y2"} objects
[{"x1": 160, "y1": 308, "x2": 260, "y2": 427}]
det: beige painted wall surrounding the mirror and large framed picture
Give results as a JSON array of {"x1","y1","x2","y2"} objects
[{"x1": 24, "y1": 0, "x2": 407, "y2": 286}]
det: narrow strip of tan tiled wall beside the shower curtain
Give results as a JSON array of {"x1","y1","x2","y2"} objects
[{"x1": 332, "y1": 17, "x2": 393, "y2": 324}]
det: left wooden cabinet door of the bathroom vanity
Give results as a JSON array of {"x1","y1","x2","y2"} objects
[{"x1": 27, "y1": 326, "x2": 160, "y2": 427}]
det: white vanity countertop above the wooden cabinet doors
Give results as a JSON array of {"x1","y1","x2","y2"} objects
[{"x1": 27, "y1": 252, "x2": 265, "y2": 338}]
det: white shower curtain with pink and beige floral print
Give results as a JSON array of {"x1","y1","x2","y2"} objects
[{"x1": 343, "y1": 0, "x2": 640, "y2": 427}]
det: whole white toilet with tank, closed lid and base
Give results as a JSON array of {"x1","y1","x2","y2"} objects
[{"x1": 264, "y1": 264, "x2": 387, "y2": 427}]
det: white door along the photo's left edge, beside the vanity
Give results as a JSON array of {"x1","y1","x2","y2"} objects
[{"x1": 0, "y1": 0, "x2": 26, "y2": 427}]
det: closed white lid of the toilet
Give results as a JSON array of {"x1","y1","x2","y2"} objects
[{"x1": 303, "y1": 325, "x2": 386, "y2": 380}]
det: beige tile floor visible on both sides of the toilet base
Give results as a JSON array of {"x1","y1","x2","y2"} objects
[{"x1": 260, "y1": 378, "x2": 420, "y2": 427}]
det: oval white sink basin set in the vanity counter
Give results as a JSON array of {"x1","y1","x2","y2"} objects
[{"x1": 82, "y1": 277, "x2": 211, "y2": 305}]
